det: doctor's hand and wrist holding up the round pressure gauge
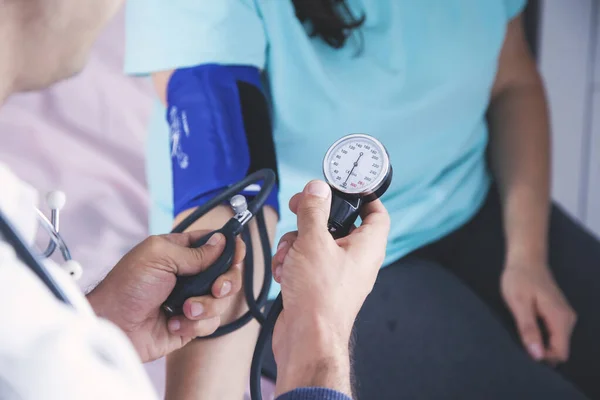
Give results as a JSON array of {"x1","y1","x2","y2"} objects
[{"x1": 273, "y1": 181, "x2": 390, "y2": 395}]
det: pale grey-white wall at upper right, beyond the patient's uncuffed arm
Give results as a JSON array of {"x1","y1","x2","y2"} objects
[{"x1": 539, "y1": 0, "x2": 600, "y2": 236}]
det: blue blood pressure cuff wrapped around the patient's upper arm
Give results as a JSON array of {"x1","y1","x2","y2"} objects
[{"x1": 167, "y1": 64, "x2": 279, "y2": 215}]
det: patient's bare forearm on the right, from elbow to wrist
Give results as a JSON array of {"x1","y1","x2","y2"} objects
[{"x1": 489, "y1": 82, "x2": 550, "y2": 265}]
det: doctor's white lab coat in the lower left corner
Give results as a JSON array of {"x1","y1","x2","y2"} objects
[{"x1": 0, "y1": 163, "x2": 156, "y2": 400}]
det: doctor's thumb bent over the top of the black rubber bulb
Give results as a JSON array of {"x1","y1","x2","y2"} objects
[{"x1": 171, "y1": 233, "x2": 225, "y2": 275}]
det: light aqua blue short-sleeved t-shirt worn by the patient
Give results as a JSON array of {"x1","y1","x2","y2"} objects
[{"x1": 126, "y1": 0, "x2": 526, "y2": 296}]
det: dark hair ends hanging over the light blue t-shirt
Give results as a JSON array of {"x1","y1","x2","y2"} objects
[{"x1": 292, "y1": 0, "x2": 365, "y2": 49}]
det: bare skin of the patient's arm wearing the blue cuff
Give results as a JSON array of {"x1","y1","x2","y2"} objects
[{"x1": 153, "y1": 72, "x2": 277, "y2": 400}]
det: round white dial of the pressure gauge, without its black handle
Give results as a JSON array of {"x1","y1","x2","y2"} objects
[{"x1": 323, "y1": 134, "x2": 390, "y2": 196}]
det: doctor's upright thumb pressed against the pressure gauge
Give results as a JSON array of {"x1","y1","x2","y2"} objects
[{"x1": 296, "y1": 180, "x2": 331, "y2": 236}]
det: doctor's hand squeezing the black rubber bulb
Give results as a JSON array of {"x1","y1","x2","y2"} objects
[{"x1": 87, "y1": 231, "x2": 246, "y2": 362}]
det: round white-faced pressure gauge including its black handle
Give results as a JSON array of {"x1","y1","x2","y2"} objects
[{"x1": 323, "y1": 134, "x2": 392, "y2": 238}]
